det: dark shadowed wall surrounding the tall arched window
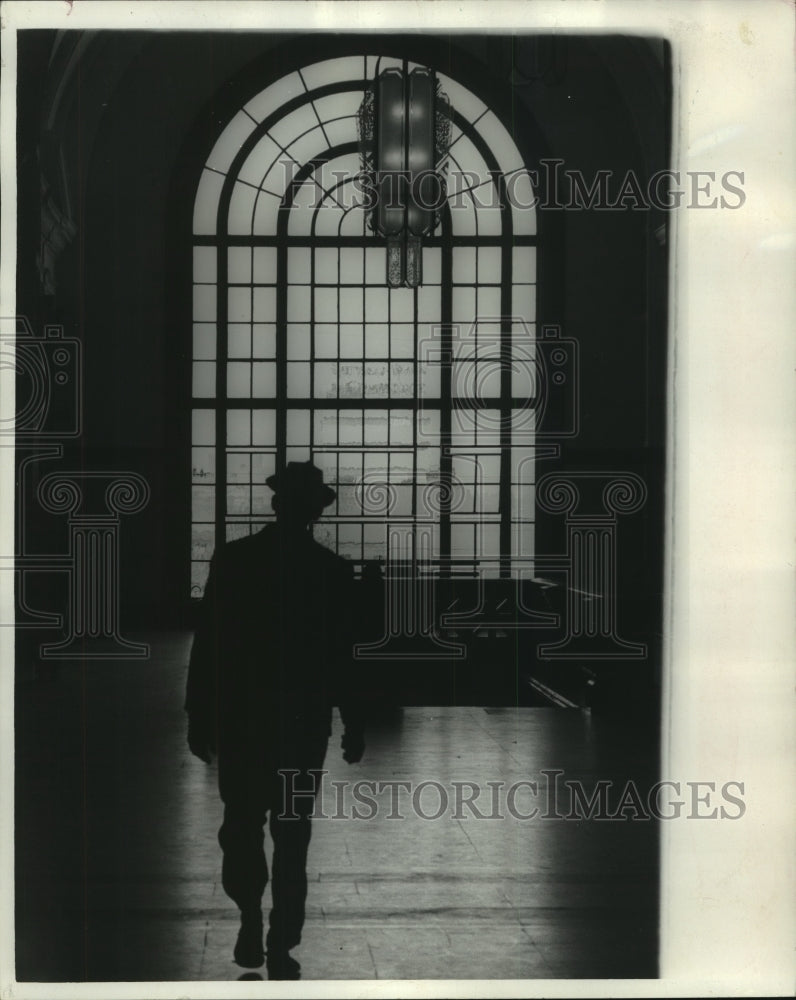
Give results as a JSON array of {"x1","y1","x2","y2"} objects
[{"x1": 18, "y1": 32, "x2": 669, "y2": 680}]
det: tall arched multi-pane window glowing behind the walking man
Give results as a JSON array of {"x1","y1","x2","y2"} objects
[{"x1": 191, "y1": 56, "x2": 536, "y2": 596}]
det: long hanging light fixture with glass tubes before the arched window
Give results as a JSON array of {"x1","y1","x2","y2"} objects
[{"x1": 359, "y1": 67, "x2": 450, "y2": 288}]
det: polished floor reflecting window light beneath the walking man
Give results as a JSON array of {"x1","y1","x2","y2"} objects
[{"x1": 16, "y1": 634, "x2": 657, "y2": 982}]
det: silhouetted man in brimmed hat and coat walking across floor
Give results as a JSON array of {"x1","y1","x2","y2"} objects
[{"x1": 185, "y1": 462, "x2": 364, "y2": 979}]
